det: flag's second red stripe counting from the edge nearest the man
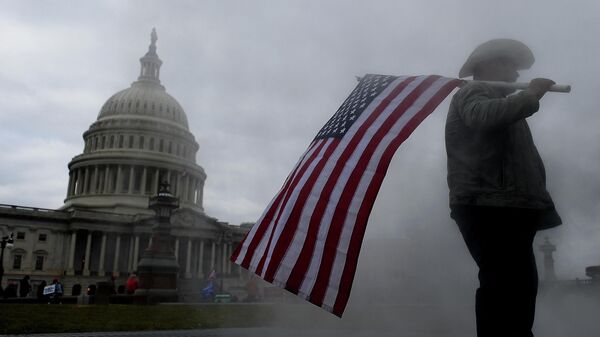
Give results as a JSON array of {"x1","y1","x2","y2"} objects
[{"x1": 310, "y1": 76, "x2": 440, "y2": 306}]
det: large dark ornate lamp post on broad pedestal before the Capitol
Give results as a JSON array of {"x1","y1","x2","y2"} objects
[{"x1": 135, "y1": 182, "x2": 179, "y2": 303}]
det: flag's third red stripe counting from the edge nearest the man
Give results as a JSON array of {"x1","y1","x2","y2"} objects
[{"x1": 282, "y1": 77, "x2": 415, "y2": 290}]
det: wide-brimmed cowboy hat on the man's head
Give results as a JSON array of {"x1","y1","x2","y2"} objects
[{"x1": 458, "y1": 39, "x2": 535, "y2": 78}]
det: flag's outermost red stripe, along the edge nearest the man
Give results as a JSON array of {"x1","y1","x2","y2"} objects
[{"x1": 333, "y1": 80, "x2": 460, "y2": 317}]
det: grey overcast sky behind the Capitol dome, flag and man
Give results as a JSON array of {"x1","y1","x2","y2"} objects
[{"x1": 0, "y1": 0, "x2": 600, "y2": 278}]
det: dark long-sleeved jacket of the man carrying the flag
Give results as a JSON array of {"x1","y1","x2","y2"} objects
[{"x1": 446, "y1": 83, "x2": 561, "y2": 228}]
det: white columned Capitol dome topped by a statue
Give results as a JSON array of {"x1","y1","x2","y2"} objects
[{"x1": 62, "y1": 30, "x2": 206, "y2": 214}]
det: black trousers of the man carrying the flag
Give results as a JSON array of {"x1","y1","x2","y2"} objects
[{"x1": 451, "y1": 206, "x2": 540, "y2": 337}]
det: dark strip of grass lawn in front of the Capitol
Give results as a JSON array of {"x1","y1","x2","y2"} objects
[{"x1": 0, "y1": 304, "x2": 276, "y2": 334}]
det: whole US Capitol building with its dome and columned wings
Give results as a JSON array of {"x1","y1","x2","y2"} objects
[{"x1": 0, "y1": 30, "x2": 251, "y2": 295}]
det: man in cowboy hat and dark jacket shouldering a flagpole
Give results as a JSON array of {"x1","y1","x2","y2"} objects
[{"x1": 446, "y1": 39, "x2": 561, "y2": 337}]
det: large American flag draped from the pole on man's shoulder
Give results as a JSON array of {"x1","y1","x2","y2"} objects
[{"x1": 231, "y1": 74, "x2": 460, "y2": 317}]
